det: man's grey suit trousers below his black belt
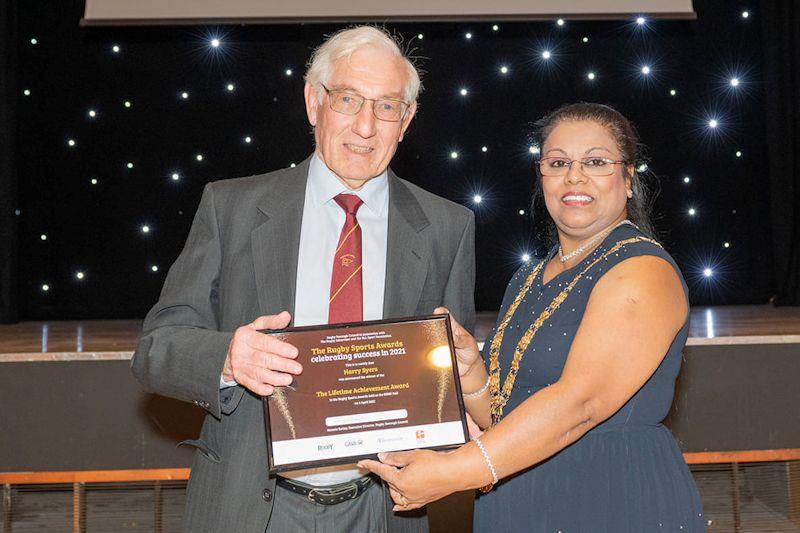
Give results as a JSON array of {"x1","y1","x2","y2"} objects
[{"x1": 266, "y1": 483, "x2": 428, "y2": 533}]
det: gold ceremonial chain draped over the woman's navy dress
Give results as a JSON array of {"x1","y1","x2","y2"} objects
[{"x1": 489, "y1": 237, "x2": 661, "y2": 425}]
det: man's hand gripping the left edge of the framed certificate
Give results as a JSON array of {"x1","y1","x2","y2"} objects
[{"x1": 222, "y1": 311, "x2": 303, "y2": 396}]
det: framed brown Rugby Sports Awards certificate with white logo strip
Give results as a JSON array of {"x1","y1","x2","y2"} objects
[{"x1": 263, "y1": 315, "x2": 469, "y2": 472}]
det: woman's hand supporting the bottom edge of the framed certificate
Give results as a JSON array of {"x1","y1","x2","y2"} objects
[{"x1": 358, "y1": 450, "x2": 467, "y2": 511}]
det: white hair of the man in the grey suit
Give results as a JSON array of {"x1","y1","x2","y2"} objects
[{"x1": 305, "y1": 26, "x2": 422, "y2": 104}]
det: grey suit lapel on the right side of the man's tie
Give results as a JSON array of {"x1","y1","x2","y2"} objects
[{"x1": 383, "y1": 170, "x2": 430, "y2": 318}]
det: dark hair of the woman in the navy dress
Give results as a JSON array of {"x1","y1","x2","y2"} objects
[{"x1": 531, "y1": 102, "x2": 656, "y2": 246}]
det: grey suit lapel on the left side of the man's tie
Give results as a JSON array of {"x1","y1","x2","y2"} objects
[{"x1": 250, "y1": 158, "x2": 311, "y2": 315}]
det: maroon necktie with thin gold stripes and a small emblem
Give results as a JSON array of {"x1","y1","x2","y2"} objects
[{"x1": 328, "y1": 194, "x2": 364, "y2": 324}]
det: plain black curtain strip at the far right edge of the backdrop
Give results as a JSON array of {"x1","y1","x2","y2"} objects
[{"x1": 761, "y1": 0, "x2": 800, "y2": 305}]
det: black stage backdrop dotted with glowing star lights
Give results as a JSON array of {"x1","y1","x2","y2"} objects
[{"x1": 13, "y1": 0, "x2": 774, "y2": 319}]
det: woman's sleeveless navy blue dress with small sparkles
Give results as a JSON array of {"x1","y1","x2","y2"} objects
[{"x1": 474, "y1": 225, "x2": 706, "y2": 533}]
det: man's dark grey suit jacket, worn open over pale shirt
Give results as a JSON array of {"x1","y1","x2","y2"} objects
[{"x1": 132, "y1": 159, "x2": 475, "y2": 533}]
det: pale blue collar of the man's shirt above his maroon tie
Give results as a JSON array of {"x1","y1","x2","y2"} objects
[{"x1": 308, "y1": 152, "x2": 389, "y2": 215}]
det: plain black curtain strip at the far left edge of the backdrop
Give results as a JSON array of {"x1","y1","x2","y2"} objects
[{"x1": 0, "y1": 0, "x2": 18, "y2": 323}]
